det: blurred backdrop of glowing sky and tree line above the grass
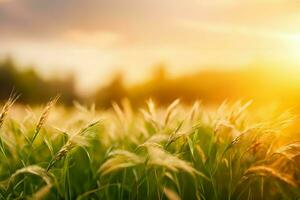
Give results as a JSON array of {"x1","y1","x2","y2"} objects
[{"x1": 0, "y1": 0, "x2": 300, "y2": 108}]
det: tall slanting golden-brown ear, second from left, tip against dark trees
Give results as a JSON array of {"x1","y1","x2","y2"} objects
[{"x1": 31, "y1": 95, "x2": 60, "y2": 144}]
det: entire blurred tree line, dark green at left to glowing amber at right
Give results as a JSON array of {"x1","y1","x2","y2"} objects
[{"x1": 0, "y1": 58, "x2": 300, "y2": 108}]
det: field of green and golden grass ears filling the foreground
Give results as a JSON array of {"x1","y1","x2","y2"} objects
[{"x1": 0, "y1": 95, "x2": 300, "y2": 200}]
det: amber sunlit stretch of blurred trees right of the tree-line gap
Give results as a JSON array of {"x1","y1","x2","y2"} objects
[{"x1": 94, "y1": 64, "x2": 300, "y2": 109}]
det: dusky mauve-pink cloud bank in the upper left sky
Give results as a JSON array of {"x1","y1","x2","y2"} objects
[{"x1": 0, "y1": 0, "x2": 183, "y2": 37}]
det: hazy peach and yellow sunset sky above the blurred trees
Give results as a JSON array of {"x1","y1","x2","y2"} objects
[{"x1": 0, "y1": 0, "x2": 300, "y2": 91}]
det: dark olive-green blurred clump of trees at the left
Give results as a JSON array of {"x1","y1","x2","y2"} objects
[{"x1": 0, "y1": 57, "x2": 79, "y2": 105}]
